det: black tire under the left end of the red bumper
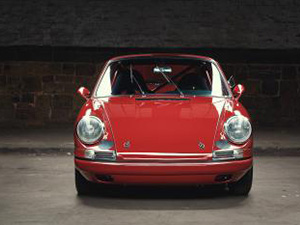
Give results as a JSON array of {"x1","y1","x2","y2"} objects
[{"x1": 75, "y1": 169, "x2": 97, "y2": 195}]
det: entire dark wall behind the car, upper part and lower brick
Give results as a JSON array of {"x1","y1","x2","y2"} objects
[{"x1": 0, "y1": 0, "x2": 300, "y2": 127}]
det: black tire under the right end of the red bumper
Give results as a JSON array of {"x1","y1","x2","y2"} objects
[{"x1": 228, "y1": 168, "x2": 253, "y2": 196}]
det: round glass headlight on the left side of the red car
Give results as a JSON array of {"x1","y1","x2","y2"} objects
[{"x1": 76, "y1": 116, "x2": 104, "y2": 144}]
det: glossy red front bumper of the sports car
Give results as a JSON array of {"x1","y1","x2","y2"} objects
[{"x1": 75, "y1": 157, "x2": 253, "y2": 184}]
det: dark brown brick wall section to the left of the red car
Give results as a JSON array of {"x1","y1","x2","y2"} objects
[{"x1": 0, "y1": 61, "x2": 101, "y2": 126}]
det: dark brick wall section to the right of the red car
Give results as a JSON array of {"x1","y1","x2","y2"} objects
[{"x1": 223, "y1": 63, "x2": 300, "y2": 126}]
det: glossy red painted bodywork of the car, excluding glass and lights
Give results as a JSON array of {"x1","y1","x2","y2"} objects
[{"x1": 74, "y1": 54, "x2": 253, "y2": 184}]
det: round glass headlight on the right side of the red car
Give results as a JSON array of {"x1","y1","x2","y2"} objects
[{"x1": 224, "y1": 115, "x2": 252, "y2": 144}]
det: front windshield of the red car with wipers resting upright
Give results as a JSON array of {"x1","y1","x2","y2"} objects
[{"x1": 95, "y1": 57, "x2": 229, "y2": 97}]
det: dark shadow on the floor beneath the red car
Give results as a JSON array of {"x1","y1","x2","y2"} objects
[{"x1": 78, "y1": 186, "x2": 251, "y2": 210}]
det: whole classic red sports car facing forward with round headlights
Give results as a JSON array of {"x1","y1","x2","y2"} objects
[{"x1": 74, "y1": 54, "x2": 253, "y2": 195}]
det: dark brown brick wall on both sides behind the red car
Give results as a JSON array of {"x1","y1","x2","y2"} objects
[{"x1": 0, "y1": 48, "x2": 300, "y2": 126}]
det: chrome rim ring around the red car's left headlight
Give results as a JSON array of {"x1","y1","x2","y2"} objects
[{"x1": 76, "y1": 116, "x2": 105, "y2": 145}]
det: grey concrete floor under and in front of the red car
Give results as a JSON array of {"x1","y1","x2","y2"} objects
[{"x1": 0, "y1": 154, "x2": 300, "y2": 225}]
